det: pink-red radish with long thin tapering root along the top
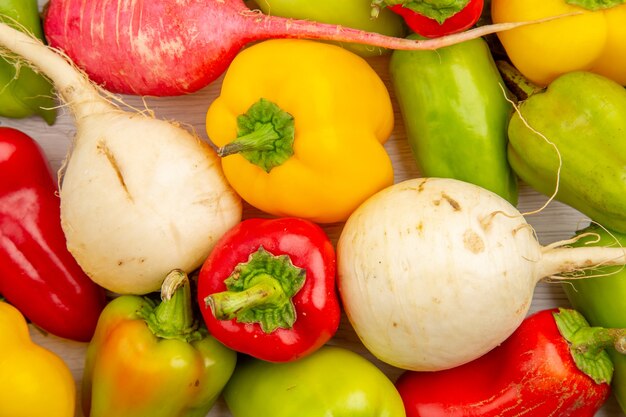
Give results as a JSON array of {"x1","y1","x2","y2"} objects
[{"x1": 44, "y1": 0, "x2": 564, "y2": 96}]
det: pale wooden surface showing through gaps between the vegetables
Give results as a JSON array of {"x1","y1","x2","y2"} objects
[{"x1": 0, "y1": 5, "x2": 624, "y2": 417}]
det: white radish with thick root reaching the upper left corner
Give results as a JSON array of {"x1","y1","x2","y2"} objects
[{"x1": 0, "y1": 23, "x2": 242, "y2": 294}]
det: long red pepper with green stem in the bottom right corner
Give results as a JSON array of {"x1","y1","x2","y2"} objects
[{"x1": 396, "y1": 309, "x2": 626, "y2": 417}]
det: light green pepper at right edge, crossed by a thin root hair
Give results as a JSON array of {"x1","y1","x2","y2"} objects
[{"x1": 504, "y1": 68, "x2": 626, "y2": 232}]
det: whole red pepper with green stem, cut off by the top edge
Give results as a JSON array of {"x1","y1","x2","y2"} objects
[{"x1": 374, "y1": 0, "x2": 484, "y2": 38}]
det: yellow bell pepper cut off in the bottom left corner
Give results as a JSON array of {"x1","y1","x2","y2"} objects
[{"x1": 0, "y1": 301, "x2": 76, "y2": 417}]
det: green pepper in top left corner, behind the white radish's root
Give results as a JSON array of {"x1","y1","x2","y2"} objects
[{"x1": 0, "y1": 0, "x2": 57, "y2": 125}]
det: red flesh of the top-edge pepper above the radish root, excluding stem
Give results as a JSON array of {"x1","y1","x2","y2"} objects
[{"x1": 383, "y1": 0, "x2": 484, "y2": 38}]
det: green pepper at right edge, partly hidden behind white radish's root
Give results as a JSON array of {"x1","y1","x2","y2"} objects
[{"x1": 563, "y1": 225, "x2": 626, "y2": 413}]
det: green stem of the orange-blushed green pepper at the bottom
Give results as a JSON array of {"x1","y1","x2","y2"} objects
[{"x1": 140, "y1": 269, "x2": 202, "y2": 342}]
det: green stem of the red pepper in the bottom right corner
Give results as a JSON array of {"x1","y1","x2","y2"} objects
[{"x1": 554, "y1": 308, "x2": 626, "y2": 384}]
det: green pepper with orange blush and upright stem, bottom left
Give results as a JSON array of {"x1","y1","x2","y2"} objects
[{"x1": 82, "y1": 270, "x2": 236, "y2": 417}]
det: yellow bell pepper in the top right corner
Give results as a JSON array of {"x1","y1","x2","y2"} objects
[{"x1": 491, "y1": 0, "x2": 626, "y2": 86}]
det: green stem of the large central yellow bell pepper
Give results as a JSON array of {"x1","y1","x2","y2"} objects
[{"x1": 217, "y1": 98, "x2": 295, "y2": 172}]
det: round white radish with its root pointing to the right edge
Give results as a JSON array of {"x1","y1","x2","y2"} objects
[{"x1": 337, "y1": 178, "x2": 626, "y2": 371}]
